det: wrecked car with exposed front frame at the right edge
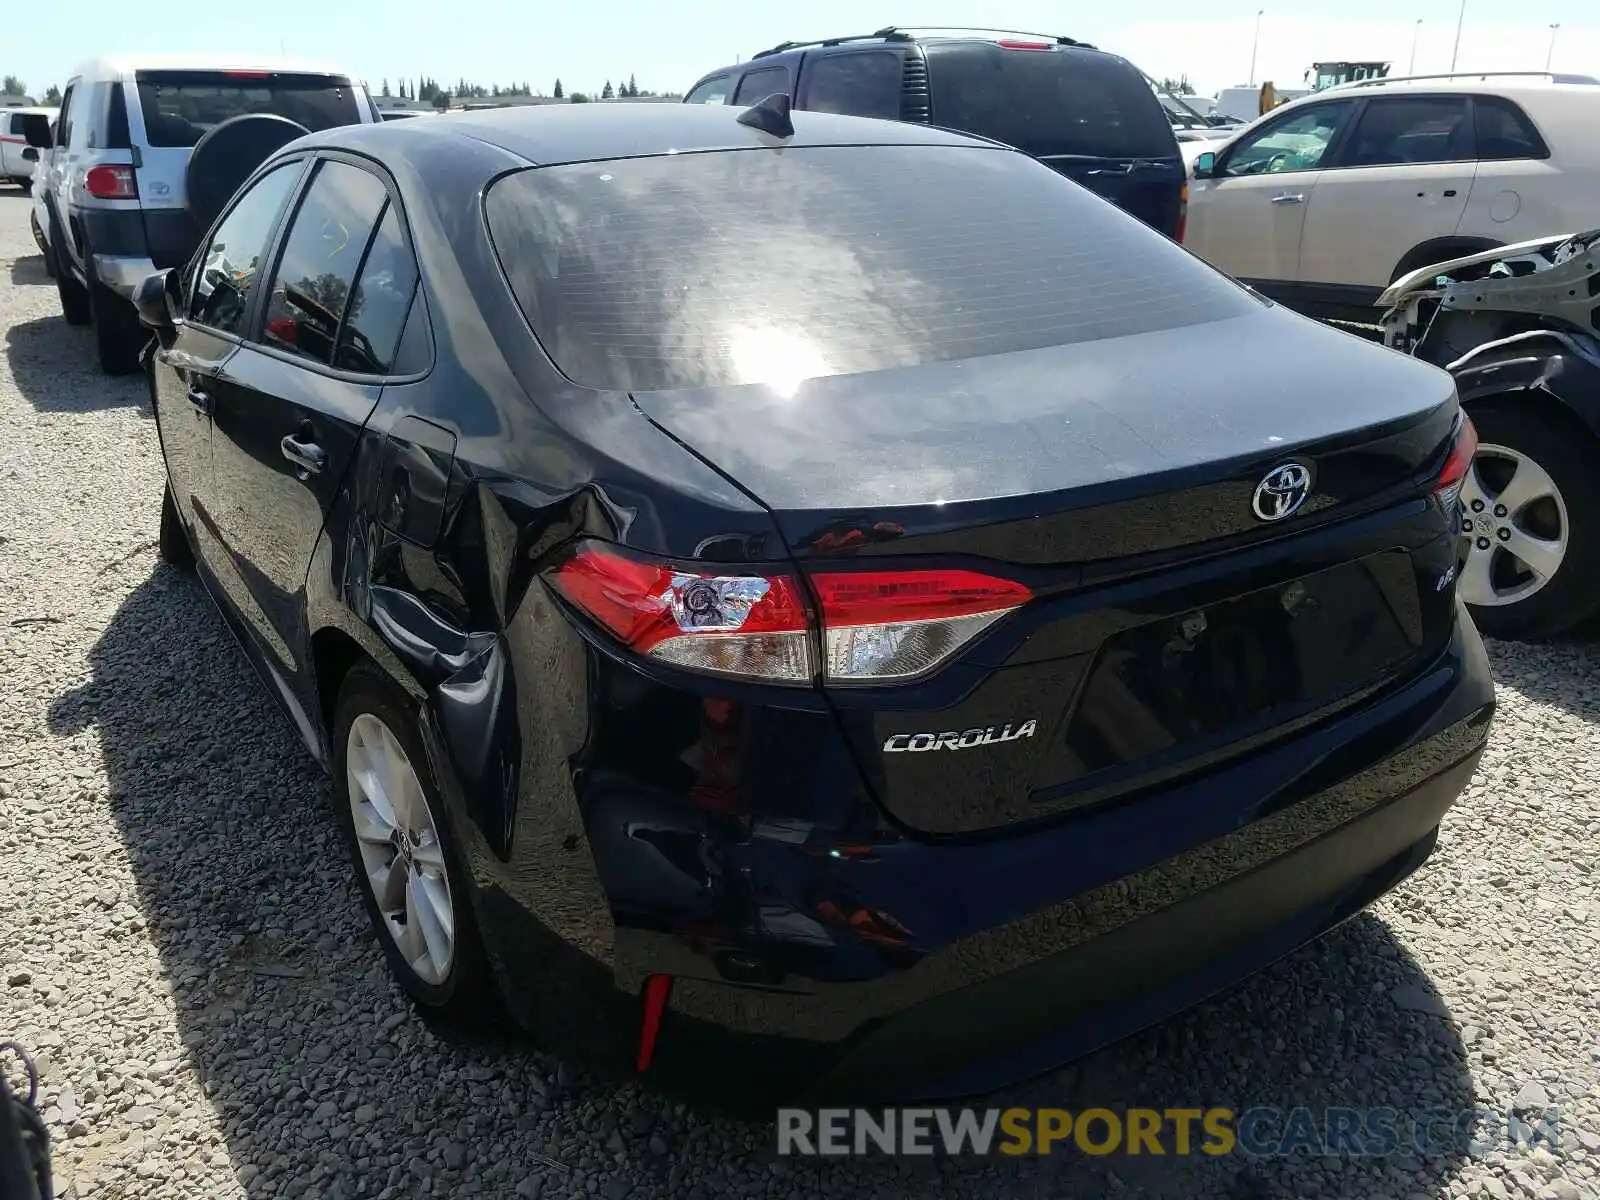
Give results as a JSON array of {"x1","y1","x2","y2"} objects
[{"x1": 1378, "y1": 229, "x2": 1600, "y2": 638}]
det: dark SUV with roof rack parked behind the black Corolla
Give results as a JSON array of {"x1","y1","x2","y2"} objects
[{"x1": 683, "y1": 26, "x2": 1187, "y2": 242}]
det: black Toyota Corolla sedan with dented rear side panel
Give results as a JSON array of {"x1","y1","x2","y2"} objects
[{"x1": 141, "y1": 101, "x2": 1494, "y2": 1099}]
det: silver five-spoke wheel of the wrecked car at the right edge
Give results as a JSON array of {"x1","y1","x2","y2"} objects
[{"x1": 1458, "y1": 397, "x2": 1600, "y2": 640}]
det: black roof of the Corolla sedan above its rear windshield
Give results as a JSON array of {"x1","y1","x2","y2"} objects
[{"x1": 308, "y1": 102, "x2": 995, "y2": 165}]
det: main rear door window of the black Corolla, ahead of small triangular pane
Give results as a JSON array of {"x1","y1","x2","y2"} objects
[{"x1": 261, "y1": 162, "x2": 389, "y2": 366}]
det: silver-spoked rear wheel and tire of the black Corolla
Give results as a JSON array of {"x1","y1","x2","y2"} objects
[{"x1": 331, "y1": 662, "x2": 496, "y2": 1027}]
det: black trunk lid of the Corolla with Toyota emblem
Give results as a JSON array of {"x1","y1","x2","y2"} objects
[{"x1": 635, "y1": 307, "x2": 1458, "y2": 834}]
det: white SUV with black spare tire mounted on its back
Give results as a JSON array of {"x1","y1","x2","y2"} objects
[{"x1": 34, "y1": 54, "x2": 378, "y2": 374}]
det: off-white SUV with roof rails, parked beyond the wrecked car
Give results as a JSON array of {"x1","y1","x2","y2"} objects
[{"x1": 1184, "y1": 74, "x2": 1600, "y2": 322}]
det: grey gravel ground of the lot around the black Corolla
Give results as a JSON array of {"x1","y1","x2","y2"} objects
[{"x1": 0, "y1": 189, "x2": 1600, "y2": 1200}]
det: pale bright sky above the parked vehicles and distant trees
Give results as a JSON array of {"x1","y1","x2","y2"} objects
[{"x1": 0, "y1": 0, "x2": 1600, "y2": 94}]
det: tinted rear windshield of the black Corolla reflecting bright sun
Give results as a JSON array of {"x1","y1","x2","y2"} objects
[{"x1": 485, "y1": 144, "x2": 1254, "y2": 390}]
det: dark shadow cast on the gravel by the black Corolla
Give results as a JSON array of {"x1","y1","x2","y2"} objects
[{"x1": 51, "y1": 566, "x2": 1472, "y2": 1200}]
